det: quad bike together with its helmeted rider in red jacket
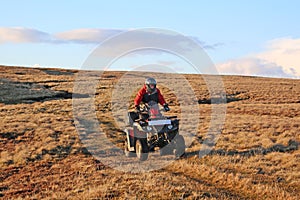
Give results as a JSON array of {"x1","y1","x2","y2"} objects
[{"x1": 124, "y1": 78, "x2": 185, "y2": 161}]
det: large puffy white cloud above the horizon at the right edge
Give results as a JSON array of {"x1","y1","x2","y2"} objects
[{"x1": 217, "y1": 38, "x2": 300, "y2": 78}]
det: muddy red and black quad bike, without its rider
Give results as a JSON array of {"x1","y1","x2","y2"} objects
[{"x1": 125, "y1": 103, "x2": 185, "y2": 161}]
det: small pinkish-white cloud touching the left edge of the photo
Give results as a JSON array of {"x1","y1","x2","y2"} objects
[{"x1": 0, "y1": 27, "x2": 52, "y2": 43}]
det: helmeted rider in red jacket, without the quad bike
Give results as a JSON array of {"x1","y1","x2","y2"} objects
[{"x1": 134, "y1": 78, "x2": 170, "y2": 112}]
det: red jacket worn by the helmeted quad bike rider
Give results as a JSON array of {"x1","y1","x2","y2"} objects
[{"x1": 134, "y1": 85, "x2": 166, "y2": 106}]
